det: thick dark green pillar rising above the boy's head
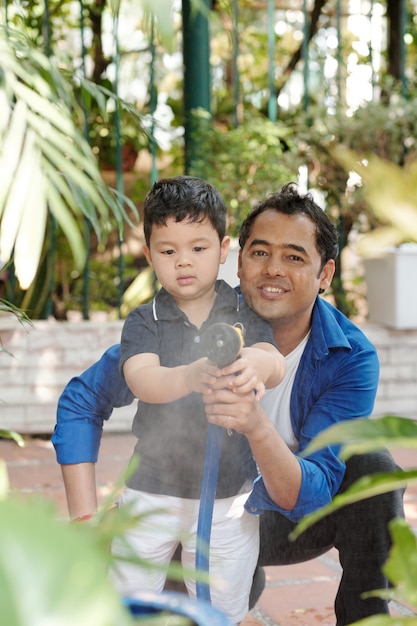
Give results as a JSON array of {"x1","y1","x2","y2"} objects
[{"x1": 182, "y1": 0, "x2": 211, "y2": 174}]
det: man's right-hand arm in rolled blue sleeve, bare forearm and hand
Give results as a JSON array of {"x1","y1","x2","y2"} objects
[{"x1": 204, "y1": 342, "x2": 378, "y2": 522}]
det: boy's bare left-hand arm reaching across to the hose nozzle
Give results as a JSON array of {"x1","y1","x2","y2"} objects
[{"x1": 123, "y1": 353, "x2": 220, "y2": 404}]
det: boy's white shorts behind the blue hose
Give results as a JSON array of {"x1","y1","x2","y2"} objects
[{"x1": 112, "y1": 488, "x2": 259, "y2": 624}]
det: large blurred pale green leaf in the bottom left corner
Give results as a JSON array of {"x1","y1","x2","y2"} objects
[{"x1": 0, "y1": 498, "x2": 134, "y2": 626}]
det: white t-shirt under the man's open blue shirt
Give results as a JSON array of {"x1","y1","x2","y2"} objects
[{"x1": 261, "y1": 332, "x2": 310, "y2": 452}]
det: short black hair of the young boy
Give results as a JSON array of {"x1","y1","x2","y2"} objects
[{"x1": 143, "y1": 176, "x2": 226, "y2": 246}]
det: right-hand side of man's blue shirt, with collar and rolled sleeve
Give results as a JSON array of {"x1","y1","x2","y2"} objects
[{"x1": 246, "y1": 298, "x2": 379, "y2": 522}]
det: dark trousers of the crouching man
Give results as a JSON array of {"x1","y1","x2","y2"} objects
[{"x1": 255, "y1": 450, "x2": 404, "y2": 626}]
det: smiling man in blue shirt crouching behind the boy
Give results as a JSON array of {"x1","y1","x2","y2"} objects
[{"x1": 54, "y1": 185, "x2": 404, "y2": 626}]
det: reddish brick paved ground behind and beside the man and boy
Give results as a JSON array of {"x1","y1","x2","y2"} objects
[{"x1": 0, "y1": 433, "x2": 417, "y2": 626}]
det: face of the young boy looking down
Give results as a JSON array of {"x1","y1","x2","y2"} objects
[{"x1": 144, "y1": 218, "x2": 230, "y2": 307}]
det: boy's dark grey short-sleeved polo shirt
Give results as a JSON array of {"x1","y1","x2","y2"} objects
[{"x1": 120, "y1": 281, "x2": 275, "y2": 499}]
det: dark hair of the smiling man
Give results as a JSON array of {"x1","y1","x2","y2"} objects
[{"x1": 239, "y1": 183, "x2": 339, "y2": 268}]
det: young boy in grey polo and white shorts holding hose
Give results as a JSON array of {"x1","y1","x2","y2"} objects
[{"x1": 114, "y1": 176, "x2": 284, "y2": 623}]
